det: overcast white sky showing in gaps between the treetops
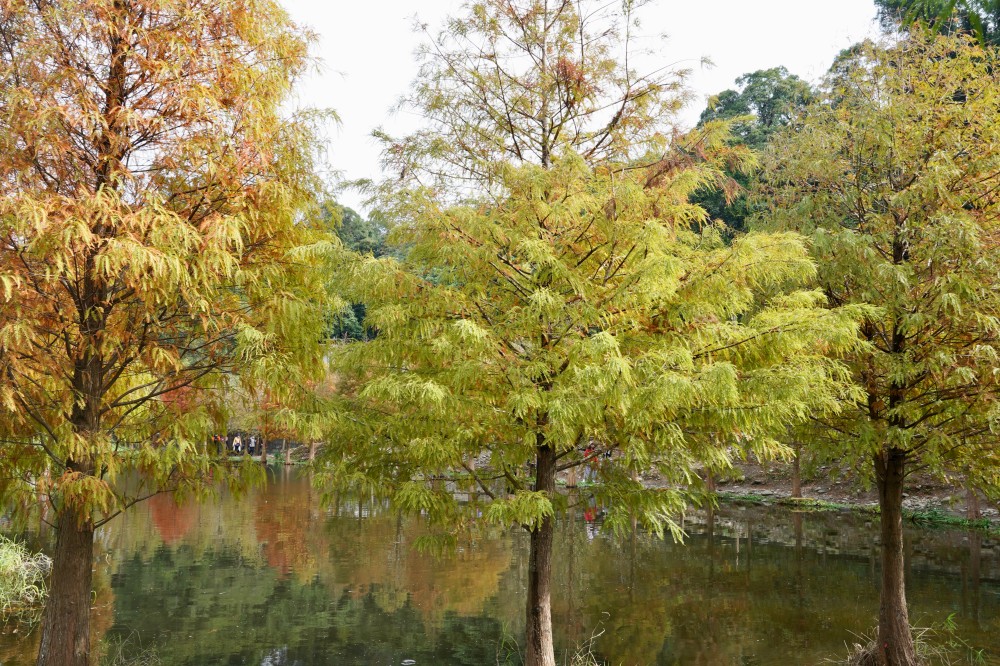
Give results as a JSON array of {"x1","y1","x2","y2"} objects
[{"x1": 281, "y1": 0, "x2": 878, "y2": 210}]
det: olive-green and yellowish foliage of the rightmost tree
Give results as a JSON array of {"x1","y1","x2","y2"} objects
[{"x1": 761, "y1": 32, "x2": 1000, "y2": 490}]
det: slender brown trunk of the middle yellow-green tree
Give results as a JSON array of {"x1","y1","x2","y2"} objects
[{"x1": 524, "y1": 444, "x2": 556, "y2": 666}]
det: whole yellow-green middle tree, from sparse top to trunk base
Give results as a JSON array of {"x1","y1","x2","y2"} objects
[{"x1": 324, "y1": 0, "x2": 868, "y2": 666}]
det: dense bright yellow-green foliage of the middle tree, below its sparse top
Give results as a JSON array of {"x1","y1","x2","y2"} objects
[{"x1": 324, "y1": 153, "x2": 858, "y2": 534}]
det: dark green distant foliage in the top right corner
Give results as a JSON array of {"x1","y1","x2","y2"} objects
[{"x1": 875, "y1": 0, "x2": 1000, "y2": 45}]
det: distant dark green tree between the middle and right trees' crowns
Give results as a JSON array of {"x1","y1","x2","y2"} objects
[{"x1": 695, "y1": 67, "x2": 816, "y2": 233}]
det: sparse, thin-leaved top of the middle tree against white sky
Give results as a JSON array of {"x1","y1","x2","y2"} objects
[{"x1": 366, "y1": 0, "x2": 687, "y2": 208}]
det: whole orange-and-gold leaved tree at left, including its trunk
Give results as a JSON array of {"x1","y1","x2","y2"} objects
[{"x1": 0, "y1": 0, "x2": 331, "y2": 664}]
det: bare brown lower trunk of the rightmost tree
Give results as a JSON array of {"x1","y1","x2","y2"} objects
[{"x1": 875, "y1": 448, "x2": 917, "y2": 666}]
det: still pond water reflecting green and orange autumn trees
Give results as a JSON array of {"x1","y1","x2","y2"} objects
[{"x1": 0, "y1": 469, "x2": 1000, "y2": 666}]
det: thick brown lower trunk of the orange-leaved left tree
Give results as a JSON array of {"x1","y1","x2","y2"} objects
[{"x1": 37, "y1": 509, "x2": 94, "y2": 666}]
